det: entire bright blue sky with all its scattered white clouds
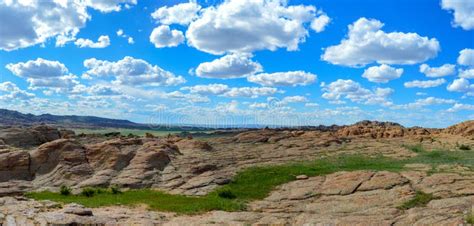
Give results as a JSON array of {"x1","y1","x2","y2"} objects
[{"x1": 0, "y1": 0, "x2": 474, "y2": 127}]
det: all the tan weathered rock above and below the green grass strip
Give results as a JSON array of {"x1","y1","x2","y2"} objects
[{"x1": 0, "y1": 122, "x2": 474, "y2": 225}]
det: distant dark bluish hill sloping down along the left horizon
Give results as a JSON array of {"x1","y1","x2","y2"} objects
[{"x1": 0, "y1": 109, "x2": 150, "y2": 129}]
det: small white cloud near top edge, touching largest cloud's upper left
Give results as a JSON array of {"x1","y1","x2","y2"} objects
[{"x1": 151, "y1": 1, "x2": 201, "y2": 25}]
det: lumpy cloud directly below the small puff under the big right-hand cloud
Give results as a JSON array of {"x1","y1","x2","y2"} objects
[{"x1": 322, "y1": 79, "x2": 393, "y2": 106}]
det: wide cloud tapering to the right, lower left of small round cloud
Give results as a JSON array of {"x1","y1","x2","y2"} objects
[{"x1": 84, "y1": 56, "x2": 186, "y2": 86}]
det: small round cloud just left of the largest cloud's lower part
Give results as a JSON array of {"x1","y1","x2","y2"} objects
[{"x1": 150, "y1": 25, "x2": 184, "y2": 48}]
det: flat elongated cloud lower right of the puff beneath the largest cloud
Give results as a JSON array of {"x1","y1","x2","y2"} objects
[{"x1": 247, "y1": 71, "x2": 317, "y2": 86}]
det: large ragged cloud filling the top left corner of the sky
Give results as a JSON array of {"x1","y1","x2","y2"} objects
[{"x1": 0, "y1": 0, "x2": 136, "y2": 51}]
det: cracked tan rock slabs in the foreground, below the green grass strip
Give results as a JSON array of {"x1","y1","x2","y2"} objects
[{"x1": 0, "y1": 171, "x2": 474, "y2": 225}]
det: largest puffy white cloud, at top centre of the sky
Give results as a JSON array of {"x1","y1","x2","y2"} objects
[{"x1": 186, "y1": 0, "x2": 322, "y2": 54}]
